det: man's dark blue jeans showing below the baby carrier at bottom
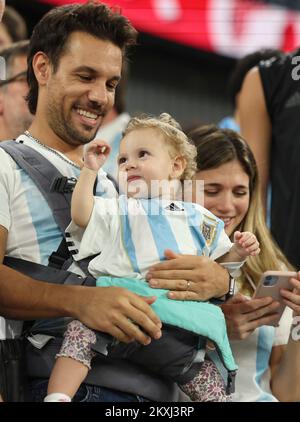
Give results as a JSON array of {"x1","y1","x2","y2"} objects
[{"x1": 29, "y1": 379, "x2": 149, "y2": 403}]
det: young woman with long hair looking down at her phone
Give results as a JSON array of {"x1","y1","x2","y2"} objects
[{"x1": 190, "y1": 126, "x2": 300, "y2": 401}]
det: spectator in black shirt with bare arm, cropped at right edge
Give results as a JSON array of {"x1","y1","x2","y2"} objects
[{"x1": 239, "y1": 49, "x2": 300, "y2": 270}]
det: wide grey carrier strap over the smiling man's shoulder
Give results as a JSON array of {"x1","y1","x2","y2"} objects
[{"x1": 0, "y1": 141, "x2": 71, "y2": 233}]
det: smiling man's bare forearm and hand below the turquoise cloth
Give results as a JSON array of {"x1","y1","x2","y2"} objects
[{"x1": 0, "y1": 225, "x2": 161, "y2": 344}]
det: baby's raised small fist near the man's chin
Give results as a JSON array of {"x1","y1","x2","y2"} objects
[{"x1": 84, "y1": 139, "x2": 111, "y2": 171}]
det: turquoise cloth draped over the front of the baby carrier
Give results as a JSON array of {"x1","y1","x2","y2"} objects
[{"x1": 97, "y1": 277, "x2": 237, "y2": 371}]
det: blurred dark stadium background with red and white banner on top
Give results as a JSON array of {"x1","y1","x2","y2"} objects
[{"x1": 7, "y1": 0, "x2": 300, "y2": 127}]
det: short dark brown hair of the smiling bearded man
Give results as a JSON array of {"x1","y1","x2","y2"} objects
[{"x1": 27, "y1": 2, "x2": 137, "y2": 114}]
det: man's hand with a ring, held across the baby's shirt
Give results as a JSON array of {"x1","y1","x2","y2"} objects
[{"x1": 146, "y1": 249, "x2": 229, "y2": 301}]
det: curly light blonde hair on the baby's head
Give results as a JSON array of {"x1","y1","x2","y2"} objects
[{"x1": 123, "y1": 113, "x2": 197, "y2": 181}]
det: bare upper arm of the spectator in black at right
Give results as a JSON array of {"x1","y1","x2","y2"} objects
[{"x1": 237, "y1": 67, "x2": 272, "y2": 208}]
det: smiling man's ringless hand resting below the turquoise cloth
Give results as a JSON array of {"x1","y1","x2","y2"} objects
[{"x1": 74, "y1": 287, "x2": 162, "y2": 345}]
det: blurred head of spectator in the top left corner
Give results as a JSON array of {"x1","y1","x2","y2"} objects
[{"x1": 0, "y1": 6, "x2": 28, "y2": 48}]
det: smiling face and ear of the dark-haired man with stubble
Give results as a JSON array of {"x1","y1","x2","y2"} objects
[{"x1": 37, "y1": 31, "x2": 122, "y2": 146}]
